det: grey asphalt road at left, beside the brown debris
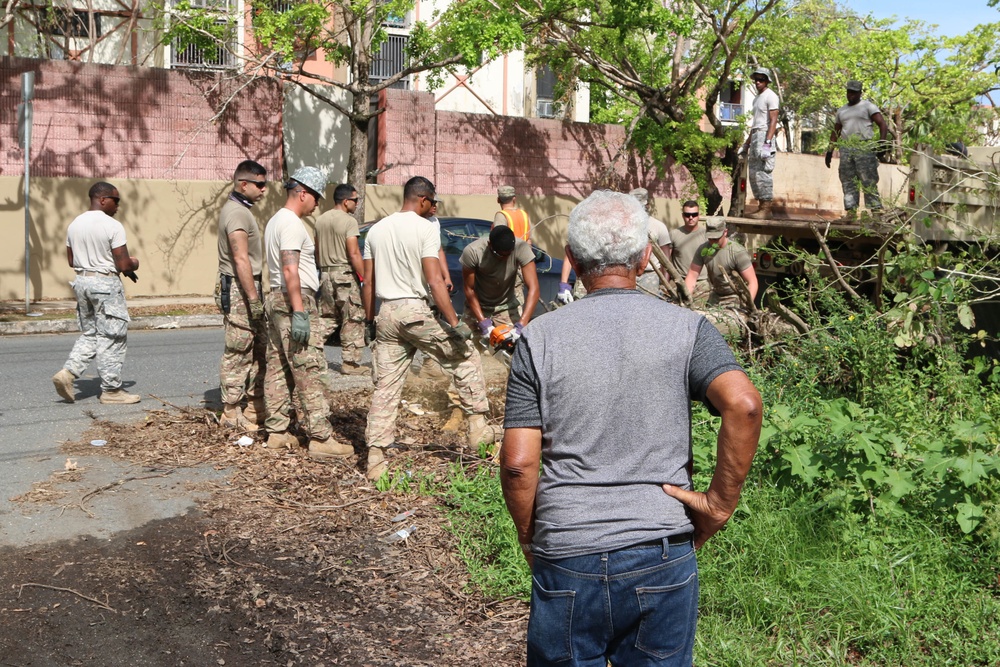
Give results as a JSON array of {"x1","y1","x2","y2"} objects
[{"x1": 0, "y1": 328, "x2": 369, "y2": 546}]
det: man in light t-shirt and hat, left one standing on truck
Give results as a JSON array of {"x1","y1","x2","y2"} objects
[{"x1": 743, "y1": 67, "x2": 780, "y2": 220}]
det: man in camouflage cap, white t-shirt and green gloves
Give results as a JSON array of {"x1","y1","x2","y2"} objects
[{"x1": 264, "y1": 167, "x2": 354, "y2": 460}]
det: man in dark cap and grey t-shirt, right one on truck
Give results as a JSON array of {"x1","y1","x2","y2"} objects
[{"x1": 826, "y1": 81, "x2": 889, "y2": 218}]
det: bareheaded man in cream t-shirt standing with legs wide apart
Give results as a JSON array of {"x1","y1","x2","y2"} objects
[{"x1": 361, "y1": 176, "x2": 500, "y2": 479}]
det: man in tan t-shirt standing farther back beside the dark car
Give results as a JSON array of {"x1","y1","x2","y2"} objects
[{"x1": 316, "y1": 183, "x2": 367, "y2": 375}]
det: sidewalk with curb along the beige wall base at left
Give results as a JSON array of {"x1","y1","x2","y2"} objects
[{"x1": 0, "y1": 296, "x2": 222, "y2": 336}]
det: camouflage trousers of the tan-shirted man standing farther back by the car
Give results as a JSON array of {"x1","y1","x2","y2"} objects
[{"x1": 318, "y1": 266, "x2": 365, "y2": 366}]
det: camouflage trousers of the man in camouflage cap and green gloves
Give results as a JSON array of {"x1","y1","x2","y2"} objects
[{"x1": 264, "y1": 291, "x2": 333, "y2": 440}]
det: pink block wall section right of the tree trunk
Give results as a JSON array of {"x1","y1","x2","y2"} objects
[{"x1": 378, "y1": 90, "x2": 729, "y2": 199}]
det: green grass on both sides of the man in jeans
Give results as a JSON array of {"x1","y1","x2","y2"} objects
[{"x1": 442, "y1": 468, "x2": 1000, "y2": 667}]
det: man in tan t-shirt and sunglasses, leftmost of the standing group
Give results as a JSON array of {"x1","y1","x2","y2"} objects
[{"x1": 215, "y1": 160, "x2": 267, "y2": 431}]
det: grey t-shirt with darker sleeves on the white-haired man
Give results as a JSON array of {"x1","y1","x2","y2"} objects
[{"x1": 504, "y1": 289, "x2": 742, "y2": 558}]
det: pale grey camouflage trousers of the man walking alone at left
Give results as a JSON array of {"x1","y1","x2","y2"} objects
[{"x1": 63, "y1": 275, "x2": 129, "y2": 392}]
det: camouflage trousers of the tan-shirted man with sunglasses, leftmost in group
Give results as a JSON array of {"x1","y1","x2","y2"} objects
[{"x1": 215, "y1": 278, "x2": 267, "y2": 405}]
